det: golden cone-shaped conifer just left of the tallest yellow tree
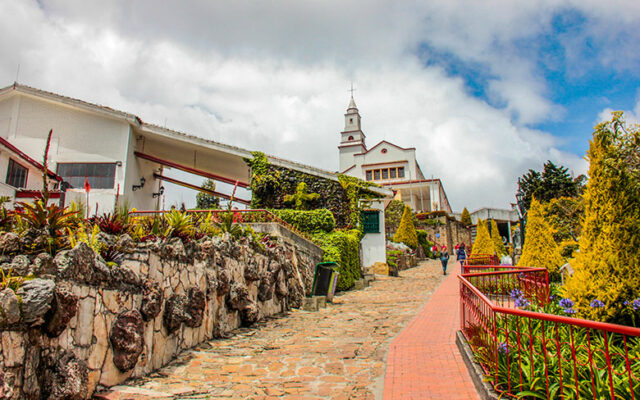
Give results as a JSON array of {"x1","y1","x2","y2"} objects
[{"x1": 518, "y1": 197, "x2": 564, "y2": 280}]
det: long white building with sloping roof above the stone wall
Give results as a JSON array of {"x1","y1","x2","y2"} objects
[{"x1": 0, "y1": 84, "x2": 393, "y2": 266}]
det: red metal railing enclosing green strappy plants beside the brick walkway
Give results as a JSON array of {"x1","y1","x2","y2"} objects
[{"x1": 459, "y1": 266, "x2": 640, "y2": 400}]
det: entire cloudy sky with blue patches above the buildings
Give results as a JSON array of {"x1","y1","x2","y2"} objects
[{"x1": 0, "y1": 0, "x2": 640, "y2": 211}]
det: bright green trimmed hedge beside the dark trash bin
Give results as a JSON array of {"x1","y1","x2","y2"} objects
[{"x1": 314, "y1": 229, "x2": 362, "y2": 291}]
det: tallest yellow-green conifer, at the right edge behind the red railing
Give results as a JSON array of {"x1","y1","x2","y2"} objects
[{"x1": 565, "y1": 112, "x2": 640, "y2": 324}]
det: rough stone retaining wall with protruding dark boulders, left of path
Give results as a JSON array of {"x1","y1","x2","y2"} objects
[{"x1": 0, "y1": 228, "x2": 322, "y2": 399}]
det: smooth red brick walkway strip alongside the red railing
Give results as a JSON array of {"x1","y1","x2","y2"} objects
[{"x1": 384, "y1": 260, "x2": 480, "y2": 400}]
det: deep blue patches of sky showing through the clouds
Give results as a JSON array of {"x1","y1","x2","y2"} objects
[{"x1": 418, "y1": 5, "x2": 640, "y2": 159}]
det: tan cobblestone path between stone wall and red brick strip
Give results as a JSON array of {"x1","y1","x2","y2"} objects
[{"x1": 100, "y1": 261, "x2": 443, "y2": 400}]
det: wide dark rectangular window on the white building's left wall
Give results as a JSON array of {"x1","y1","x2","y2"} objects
[{"x1": 58, "y1": 163, "x2": 116, "y2": 189}]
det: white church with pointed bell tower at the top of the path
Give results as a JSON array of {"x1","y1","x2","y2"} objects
[{"x1": 338, "y1": 97, "x2": 452, "y2": 213}]
